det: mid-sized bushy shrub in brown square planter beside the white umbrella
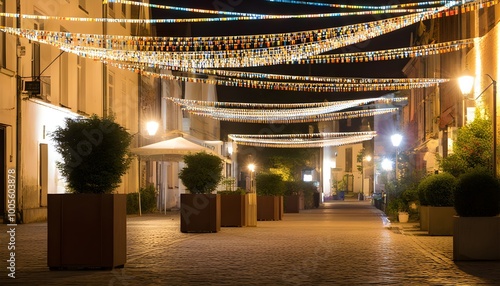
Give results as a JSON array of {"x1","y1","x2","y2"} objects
[{"x1": 179, "y1": 152, "x2": 223, "y2": 232}]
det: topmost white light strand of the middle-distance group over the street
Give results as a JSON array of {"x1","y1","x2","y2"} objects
[{"x1": 166, "y1": 97, "x2": 408, "y2": 109}]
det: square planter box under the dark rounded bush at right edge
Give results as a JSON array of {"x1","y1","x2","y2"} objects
[{"x1": 453, "y1": 216, "x2": 500, "y2": 261}]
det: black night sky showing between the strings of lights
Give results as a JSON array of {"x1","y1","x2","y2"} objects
[{"x1": 152, "y1": 0, "x2": 415, "y2": 137}]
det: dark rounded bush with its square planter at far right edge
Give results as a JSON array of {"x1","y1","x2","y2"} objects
[{"x1": 453, "y1": 168, "x2": 500, "y2": 260}]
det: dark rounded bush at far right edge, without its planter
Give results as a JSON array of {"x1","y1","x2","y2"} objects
[{"x1": 454, "y1": 169, "x2": 500, "y2": 217}]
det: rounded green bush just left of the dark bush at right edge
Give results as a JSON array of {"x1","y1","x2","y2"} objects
[{"x1": 418, "y1": 173, "x2": 457, "y2": 207}]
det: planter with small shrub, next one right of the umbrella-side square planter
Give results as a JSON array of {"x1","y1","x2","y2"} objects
[{"x1": 217, "y1": 178, "x2": 248, "y2": 227}]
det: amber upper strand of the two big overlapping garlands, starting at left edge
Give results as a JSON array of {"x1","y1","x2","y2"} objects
[{"x1": 3, "y1": 10, "x2": 436, "y2": 53}]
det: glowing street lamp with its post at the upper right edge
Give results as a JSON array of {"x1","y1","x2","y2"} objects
[{"x1": 458, "y1": 74, "x2": 497, "y2": 177}]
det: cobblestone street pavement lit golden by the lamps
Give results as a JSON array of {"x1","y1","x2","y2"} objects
[{"x1": 0, "y1": 201, "x2": 500, "y2": 285}]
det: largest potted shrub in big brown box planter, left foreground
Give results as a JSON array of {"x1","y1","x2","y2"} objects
[{"x1": 47, "y1": 115, "x2": 132, "y2": 269}]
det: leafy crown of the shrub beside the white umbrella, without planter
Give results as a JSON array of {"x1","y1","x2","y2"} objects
[{"x1": 179, "y1": 152, "x2": 223, "y2": 194}]
